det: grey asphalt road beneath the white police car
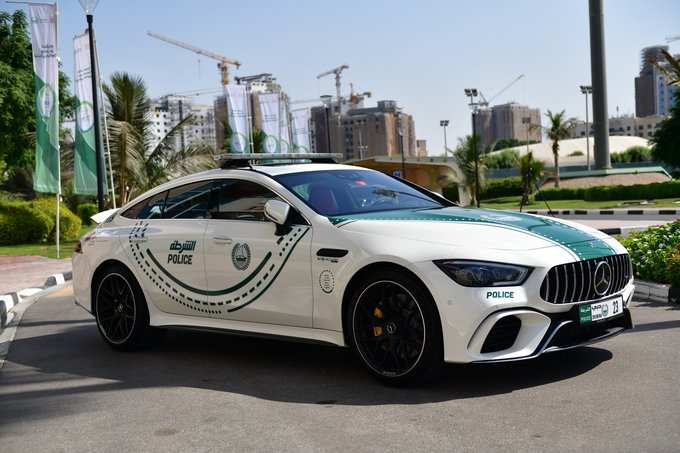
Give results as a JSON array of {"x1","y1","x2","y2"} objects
[{"x1": 0, "y1": 289, "x2": 680, "y2": 453}]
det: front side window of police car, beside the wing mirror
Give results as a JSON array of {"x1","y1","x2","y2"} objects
[{"x1": 210, "y1": 179, "x2": 278, "y2": 222}]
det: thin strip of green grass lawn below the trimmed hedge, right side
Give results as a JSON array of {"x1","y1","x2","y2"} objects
[{"x1": 481, "y1": 196, "x2": 680, "y2": 209}]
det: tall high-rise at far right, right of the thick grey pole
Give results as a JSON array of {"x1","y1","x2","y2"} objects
[{"x1": 635, "y1": 46, "x2": 680, "y2": 117}]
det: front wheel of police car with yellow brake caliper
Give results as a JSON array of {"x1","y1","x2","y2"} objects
[{"x1": 345, "y1": 269, "x2": 444, "y2": 386}]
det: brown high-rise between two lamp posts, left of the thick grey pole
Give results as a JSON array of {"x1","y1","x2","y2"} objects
[{"x1": 475, "y1": 102, "x2": 541, "y2": 148}]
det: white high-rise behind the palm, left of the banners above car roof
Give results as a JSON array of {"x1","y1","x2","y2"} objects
[{"x1": 149, "y1": 95, "x2": 215, "y2": 149}]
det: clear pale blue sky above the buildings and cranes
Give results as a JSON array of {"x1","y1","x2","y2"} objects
[{"x1": 2, "y1": 0, "x2": 680, "y2": 154}]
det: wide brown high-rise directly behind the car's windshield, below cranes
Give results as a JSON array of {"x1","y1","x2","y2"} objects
[{"x1": 312, "y1": 101, "x2": 416, "y2": 159}]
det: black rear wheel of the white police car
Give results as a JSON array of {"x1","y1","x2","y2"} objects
[{"x1": 93, "y1": 264, "x2": 151, "y2": 351}]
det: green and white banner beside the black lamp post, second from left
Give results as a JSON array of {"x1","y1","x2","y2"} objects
[{"x1": 73, "y1": 31, "x2": 99, "y2": 195}]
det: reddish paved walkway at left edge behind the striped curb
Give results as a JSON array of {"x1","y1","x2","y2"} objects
[{"x1": 0, "y1": 256, "x2": 71, "y2": 294}]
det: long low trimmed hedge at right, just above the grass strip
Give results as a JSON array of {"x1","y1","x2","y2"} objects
[{"x1": 536, "y1": 181, "x2": 680, "y2": 201}]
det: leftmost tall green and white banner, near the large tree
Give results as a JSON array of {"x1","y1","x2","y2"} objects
[{"x1": 28, "y1": 4, "x2": 61, "y2": 193}]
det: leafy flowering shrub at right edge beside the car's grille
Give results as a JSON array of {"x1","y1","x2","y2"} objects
[{"x1": 621, "y1": 220, "x2": 680, "y2": 286}]
